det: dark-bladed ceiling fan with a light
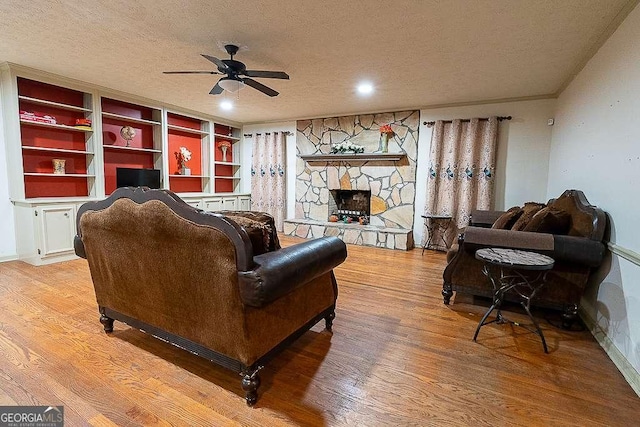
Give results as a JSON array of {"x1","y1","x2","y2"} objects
[{"x1": 164, "y1": 44, "x2": 289, "y2": 96}]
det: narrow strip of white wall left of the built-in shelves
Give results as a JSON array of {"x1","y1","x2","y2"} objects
[{"x1": 0, "y1": 88, "x2": 18, "y2": 261}]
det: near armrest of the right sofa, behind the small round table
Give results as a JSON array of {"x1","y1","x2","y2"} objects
[{"x1": 464, "y1": 226, "x2": 605, "y2": 267}]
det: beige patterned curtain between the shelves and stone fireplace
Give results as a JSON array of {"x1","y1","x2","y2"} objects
[{"x1": 251, "y1": 132, "x2": 287, "y2": 231}]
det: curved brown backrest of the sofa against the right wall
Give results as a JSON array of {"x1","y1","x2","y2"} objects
[{"x1": 547, "y1": 190, "x2": 607, "y2": 242}]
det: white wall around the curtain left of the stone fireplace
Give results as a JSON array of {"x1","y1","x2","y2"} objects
[{"x1": 241, "y1": 122, "x2": 296, "y2": 218}]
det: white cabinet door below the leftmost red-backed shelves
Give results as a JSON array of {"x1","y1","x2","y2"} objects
[{"x1": 36, "y1": 206, "x2": 76, "y2": 257}]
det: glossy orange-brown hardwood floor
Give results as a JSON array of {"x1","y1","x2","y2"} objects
[{"x1": 0, "y1": 237, "x2": 640, "y2": 426}]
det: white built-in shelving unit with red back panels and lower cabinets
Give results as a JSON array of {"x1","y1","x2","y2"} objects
[{"x1": 0, "y1": 64, "x2": 251, "y2": 265}]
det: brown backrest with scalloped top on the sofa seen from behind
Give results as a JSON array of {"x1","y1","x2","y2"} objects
[{"x1": 78, "y1": 188, "x2": 253, "y2": 358}]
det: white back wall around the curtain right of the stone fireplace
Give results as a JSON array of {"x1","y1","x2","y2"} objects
[{"x1": 414, "y1": 99, "x2": 559, "y2": 245}]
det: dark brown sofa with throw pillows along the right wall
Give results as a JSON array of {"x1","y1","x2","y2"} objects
[{"x1": 442, "y1": 190, "x2": 606, "y2": 328}]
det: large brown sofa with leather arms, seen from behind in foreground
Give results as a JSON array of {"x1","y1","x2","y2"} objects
[{"x1": 75, "y1": 188, "x2": 347, "y2": 405}]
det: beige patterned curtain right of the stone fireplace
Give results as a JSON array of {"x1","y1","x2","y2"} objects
[{"x1": 423, "y1": 117, "x2": 498, "y2": 245}]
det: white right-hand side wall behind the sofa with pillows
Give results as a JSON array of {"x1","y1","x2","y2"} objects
[{"x1": 547, "y1": 7, "x2": 640, "y2": 394}]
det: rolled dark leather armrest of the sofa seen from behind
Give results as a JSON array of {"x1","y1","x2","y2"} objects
[{"x1": 238, "y1": 237, "x2": 347, "y2": 307}]
